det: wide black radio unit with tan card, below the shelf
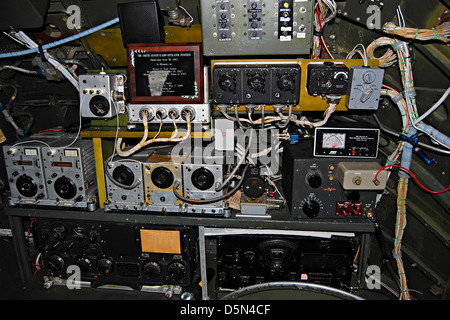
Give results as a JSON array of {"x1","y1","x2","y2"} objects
[{"x1": 32, "y1": 219, "x2": 198, "y2": 290}]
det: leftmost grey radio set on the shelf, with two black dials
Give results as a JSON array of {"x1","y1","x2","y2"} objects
[{"x1": 3, "y1": 133, "x2": 98, "y2": 211}]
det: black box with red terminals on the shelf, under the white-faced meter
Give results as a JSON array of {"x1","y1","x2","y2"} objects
[{"x1": 282, "y1": 140, "x2": 379, "y2": 222}]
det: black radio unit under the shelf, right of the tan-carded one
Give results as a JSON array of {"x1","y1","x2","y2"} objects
[{"x1": 217, "y1": 235, "x2": 357, "y2": 291}]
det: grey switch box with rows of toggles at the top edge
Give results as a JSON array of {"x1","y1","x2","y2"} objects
[{"x1": 200, "y1": 0, "x2": 314, "y2": 56}]
